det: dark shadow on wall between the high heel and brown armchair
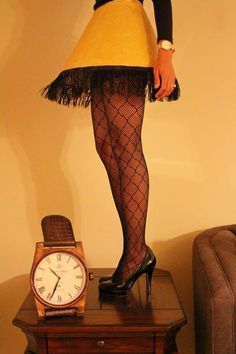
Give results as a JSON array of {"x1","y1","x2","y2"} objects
[{"x1": 153, "y1": 230, "x2": 202, "y2": 354}]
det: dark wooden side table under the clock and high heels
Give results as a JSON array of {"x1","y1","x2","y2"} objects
[{"x1": 13, "y1": 268, "x2": 187, "y2": 354}]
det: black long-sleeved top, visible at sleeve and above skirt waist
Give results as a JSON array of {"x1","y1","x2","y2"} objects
[{"x1": 93, "y1": 0, "x2": 173, "y2": 43}]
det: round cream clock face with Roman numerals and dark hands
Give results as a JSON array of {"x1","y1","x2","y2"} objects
[{"x1": 32, "y1": 252, "x2": 86, "y2": 306}]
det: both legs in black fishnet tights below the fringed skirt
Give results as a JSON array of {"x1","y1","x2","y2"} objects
[{"x1": 91, "y1": 77, "x2": 149, "y2": 281}]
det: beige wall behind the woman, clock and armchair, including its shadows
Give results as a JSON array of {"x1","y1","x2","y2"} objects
[{"x1": 0, "y1": 0, "x2": 236, "y2": 354}]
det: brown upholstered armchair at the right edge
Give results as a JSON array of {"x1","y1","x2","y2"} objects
[{"x1": 193, "y1": 224, "x2": 236, "y2": 354}]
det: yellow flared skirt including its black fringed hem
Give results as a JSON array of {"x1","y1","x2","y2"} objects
[{"x1": 42, "y1": 0, "x2": 179, "y2": 108}]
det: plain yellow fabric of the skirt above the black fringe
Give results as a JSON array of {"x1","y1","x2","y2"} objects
[{"x1": 63, "y1": 0, "x2": 157, "y2": 70}]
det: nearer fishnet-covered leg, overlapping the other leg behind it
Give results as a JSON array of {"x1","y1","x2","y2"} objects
[{"x1": 104, "y1": 78, "x2": 149, "y2": 280}]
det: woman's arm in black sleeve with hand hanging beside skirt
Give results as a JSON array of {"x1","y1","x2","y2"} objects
[{"x1": 152, "y1": 0, "x2": 175, "y2": 100}]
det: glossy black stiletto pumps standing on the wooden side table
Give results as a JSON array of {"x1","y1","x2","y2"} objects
[{"x1": 99, "y1": 246, "x2": 156, "y2": 295}]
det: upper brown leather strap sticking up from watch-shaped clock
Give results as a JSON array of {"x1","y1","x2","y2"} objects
[{"x1": 41, "y1": 215, "x2": 75, "y2": 247}]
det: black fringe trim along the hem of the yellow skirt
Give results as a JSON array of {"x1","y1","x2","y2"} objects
[{"x1": 41, "y1": 66, "x2": 180, "y2": 108}]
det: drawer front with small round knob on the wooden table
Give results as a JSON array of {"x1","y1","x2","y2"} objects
[{"x1": 48, "y1": 333, "x2": 154, "y2": 354}]
